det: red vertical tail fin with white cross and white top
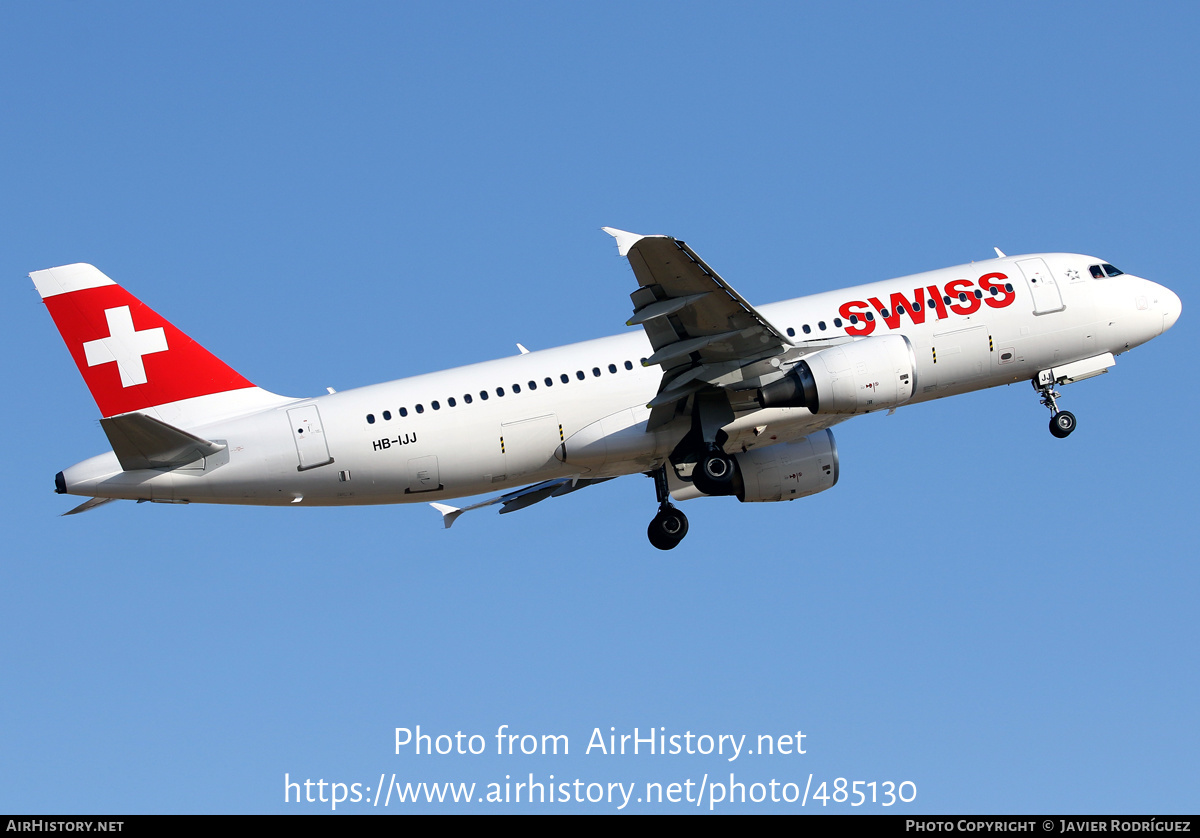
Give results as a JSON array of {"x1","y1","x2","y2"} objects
[{"x1": 29, "y1": 264, "x2": 254, "y2": 417}]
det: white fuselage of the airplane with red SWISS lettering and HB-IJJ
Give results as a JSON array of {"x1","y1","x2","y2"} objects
[{"x1": 64, "y1": 253, "x2": 1180, "y2": 505}]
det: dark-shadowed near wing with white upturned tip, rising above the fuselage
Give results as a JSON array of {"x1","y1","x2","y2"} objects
[{"x1": 604, "y1": 227, "x2": 797, "y2": 427}]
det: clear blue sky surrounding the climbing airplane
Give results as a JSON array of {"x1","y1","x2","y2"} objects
[{"x1": 0, "y1": 2, "x2": 1200, "y2": 814}]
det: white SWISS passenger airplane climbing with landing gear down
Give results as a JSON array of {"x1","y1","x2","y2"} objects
[{"x1": 30, "y1": 227, "x2": 1182, "y2": 550}]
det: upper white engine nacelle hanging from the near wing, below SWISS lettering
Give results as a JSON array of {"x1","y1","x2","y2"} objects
[{"x1": 758, "y1": 335, "x2": 917, "y2": 414}]
